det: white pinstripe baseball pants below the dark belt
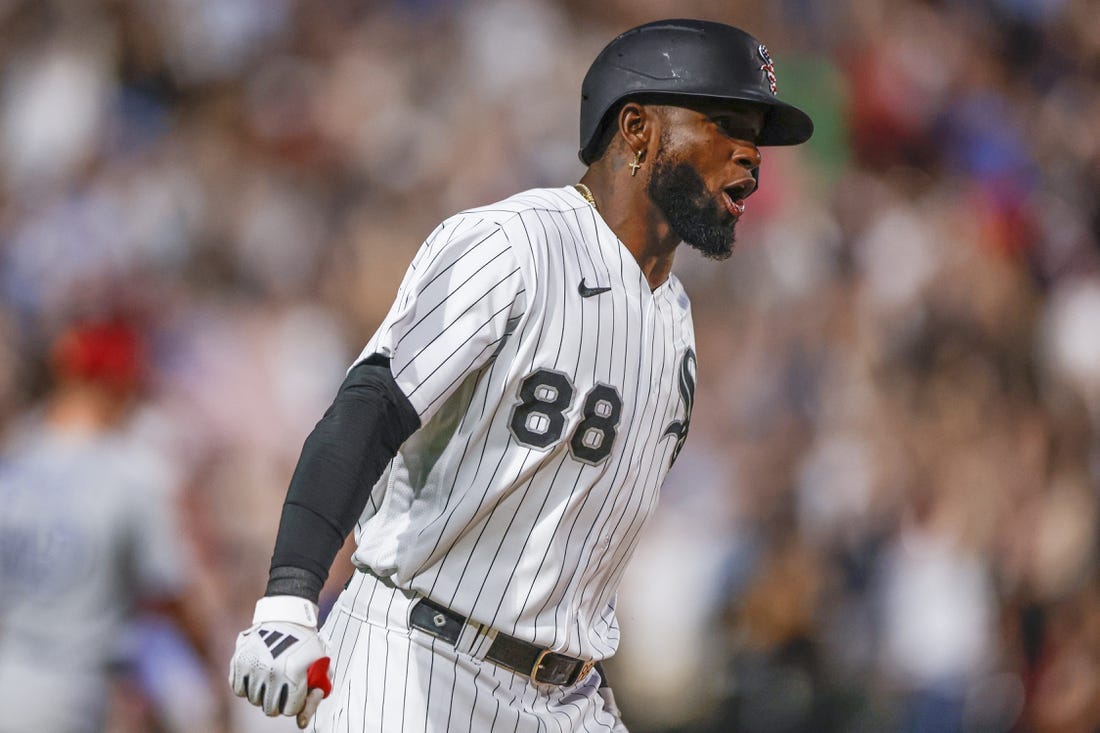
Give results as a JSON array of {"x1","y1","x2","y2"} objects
[{"x1": 310, "y1": 572, "x2": 623, "y2": 733}]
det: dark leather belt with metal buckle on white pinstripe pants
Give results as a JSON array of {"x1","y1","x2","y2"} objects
[{"x1": 409, "y1": 598, "x2": 596, "y2": 687}]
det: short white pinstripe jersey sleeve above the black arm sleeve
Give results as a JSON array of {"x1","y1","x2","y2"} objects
[{"x1": 356, "y1": 216, "x2": 526, "y2": 425}]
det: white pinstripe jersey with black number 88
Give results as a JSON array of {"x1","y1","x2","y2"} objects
[{"x1": 354, "y1": 186, "x2": 695, "y2": 659}]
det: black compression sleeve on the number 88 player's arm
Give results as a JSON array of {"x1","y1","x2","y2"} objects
[{"x1": 265, "y1": 354, "x2": 420, "y2": 603}]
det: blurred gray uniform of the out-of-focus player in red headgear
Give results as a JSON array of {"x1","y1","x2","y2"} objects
[{"x1": 0, "y1": 416, "x2": 186, "y2": 733}]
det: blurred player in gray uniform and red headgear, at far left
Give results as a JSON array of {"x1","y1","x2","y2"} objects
[{"x1": 0, "y1": 320, "x2": 209, "y2": 733}]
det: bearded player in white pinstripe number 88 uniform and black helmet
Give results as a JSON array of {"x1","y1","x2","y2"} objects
[{"x1": 229, "y1": 20, "x2": 813, "y2": 733}]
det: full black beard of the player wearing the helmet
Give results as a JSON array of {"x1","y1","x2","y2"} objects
[{"x1": 647, "y1": 154, "x2": 737, "y2": 260}]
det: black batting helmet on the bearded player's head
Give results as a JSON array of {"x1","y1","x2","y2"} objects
[{"x1": 580, "y1": 20, "x2": 814, "y2": 165}]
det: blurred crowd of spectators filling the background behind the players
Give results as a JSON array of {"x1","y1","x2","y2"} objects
[{"x1": 0, "y1": 0, "x2": 1100, "y2": 733}]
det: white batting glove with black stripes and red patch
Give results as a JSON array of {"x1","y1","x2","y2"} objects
[{"x1": 229, "y1": 595, "x2": 332, "y2": 729}]
